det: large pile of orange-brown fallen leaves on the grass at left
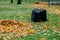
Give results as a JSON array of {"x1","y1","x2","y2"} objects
[{"x1": 0, "y1": 20, "x2": 34, "y2": 38}]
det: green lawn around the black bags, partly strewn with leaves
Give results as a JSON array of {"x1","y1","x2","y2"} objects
[{"x1": 0, "y1": 2, "x2": 60, "y2": 40}]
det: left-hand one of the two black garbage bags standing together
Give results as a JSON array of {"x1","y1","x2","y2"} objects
[{"x1": 31, "y1": 8, "x2": 41, "y2": 22}]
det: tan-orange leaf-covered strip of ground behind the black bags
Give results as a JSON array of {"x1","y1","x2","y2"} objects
[{"x1": 31, "y1": 2, "x2": 60, "y2": 15}]
